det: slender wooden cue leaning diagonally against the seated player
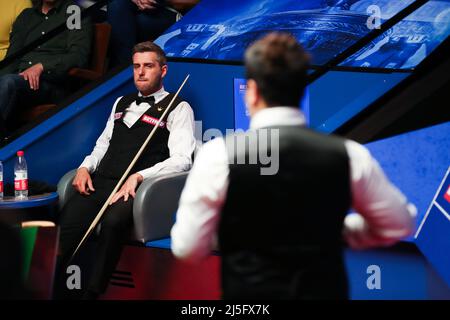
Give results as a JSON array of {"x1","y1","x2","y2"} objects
[{"x1": 70, "y1": 74, "x2": 189, "y2": 261}]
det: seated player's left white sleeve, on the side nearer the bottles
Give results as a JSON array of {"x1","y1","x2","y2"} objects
[{"x1": 79, "y1": 97, "x2": 122, "y2": 173}]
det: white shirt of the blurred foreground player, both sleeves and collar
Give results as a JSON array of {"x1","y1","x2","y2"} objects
[{"x1": 171, "y1": 107, "x2": 416, "y2": 260}]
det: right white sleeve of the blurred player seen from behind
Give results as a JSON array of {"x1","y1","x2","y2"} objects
[{"x1": 344, "y1": 140, "x2": 417, "y2": 249}]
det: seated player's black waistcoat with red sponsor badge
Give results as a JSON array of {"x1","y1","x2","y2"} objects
[{"x1": 97, "y1": 94, "x2": 182, "y2": 179}]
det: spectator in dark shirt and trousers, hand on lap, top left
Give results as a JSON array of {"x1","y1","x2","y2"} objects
[{"x1": 0, "y1": 0, "x2": 92, "y2": 134}]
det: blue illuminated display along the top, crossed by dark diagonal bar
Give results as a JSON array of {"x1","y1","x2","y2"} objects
[{"x1": 156, "y1": 0, "x2": 450, "y2": 69}]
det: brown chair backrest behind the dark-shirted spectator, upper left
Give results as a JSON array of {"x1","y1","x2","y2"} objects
[{"x1": 91, "y1": 23, "x2": 111, "y2": 75}]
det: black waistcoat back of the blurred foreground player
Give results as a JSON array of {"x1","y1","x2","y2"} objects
[{"x1": 219, "y1": 126, "x2": 351, "y2": 299}]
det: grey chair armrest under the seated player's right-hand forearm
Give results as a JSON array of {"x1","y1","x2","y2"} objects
[{"x1": 133, "y1": 172, "x2": 188, "y2": 243}]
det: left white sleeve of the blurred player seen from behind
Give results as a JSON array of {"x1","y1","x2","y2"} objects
[{"x1": 171, "y1": 138, "x2": 229, "y2": 262}]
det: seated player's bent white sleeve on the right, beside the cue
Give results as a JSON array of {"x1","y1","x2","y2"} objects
[{"x1": 138, "y1": 102, "x2": 195, "y2": 179}]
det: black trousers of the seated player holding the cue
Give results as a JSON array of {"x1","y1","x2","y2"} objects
[{"x1": 57, "y1": 176, "x2": 133, "y2": 294}]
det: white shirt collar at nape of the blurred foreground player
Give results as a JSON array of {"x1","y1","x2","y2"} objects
[{"x1": 250, "y1": 106, "x2": 306, "y2": 129}]
